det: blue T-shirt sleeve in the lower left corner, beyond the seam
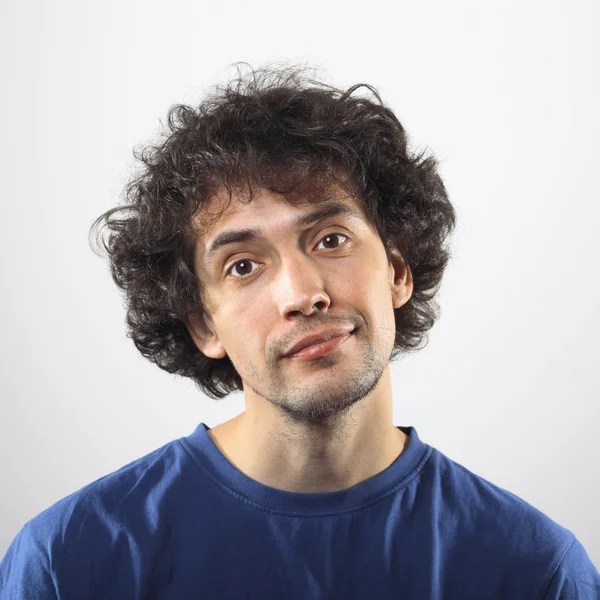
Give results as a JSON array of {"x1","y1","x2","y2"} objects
[{"x1": 0, "y1": 522, "x2": 58, "y2": 600}]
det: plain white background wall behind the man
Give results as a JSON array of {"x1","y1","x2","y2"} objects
[{"x1": 0, "y1": 0, "x2": 600, "y2": 566}]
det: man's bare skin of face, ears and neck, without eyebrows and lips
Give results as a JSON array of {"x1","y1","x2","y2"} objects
[{"x1": 186, "y1": 185, "x2": 413, "y2": 493}]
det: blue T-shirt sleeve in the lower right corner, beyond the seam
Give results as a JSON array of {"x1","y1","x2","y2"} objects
[{"x1": 544, "y1": 538, "x2": 600, "y2": 600}]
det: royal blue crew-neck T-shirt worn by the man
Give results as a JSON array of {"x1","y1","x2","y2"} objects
[{"x1": 0, "y1": 423, "x2": 600, "y2": 600}]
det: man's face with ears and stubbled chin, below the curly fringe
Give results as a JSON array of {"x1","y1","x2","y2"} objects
[{"x1": 188, "y1": 183, "x2": 412, "y2": 425}]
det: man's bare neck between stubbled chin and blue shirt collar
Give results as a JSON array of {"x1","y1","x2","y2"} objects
[{"x1": 209, "y1": 369, "x2": 407, "y2": 493}]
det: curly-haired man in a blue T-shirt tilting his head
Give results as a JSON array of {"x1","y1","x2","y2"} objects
[{"x1": 0, "y1": 65, "x2": 600, "y2": 600}]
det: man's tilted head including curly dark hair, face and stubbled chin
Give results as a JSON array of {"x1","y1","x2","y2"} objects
[{"x1": 92, "y1": 62, "x2": 455, "y2": 408}]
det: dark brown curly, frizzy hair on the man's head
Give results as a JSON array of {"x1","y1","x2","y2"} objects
[{"x1": 90, "y1": 65, "x2": 456, "y2": 399}]
